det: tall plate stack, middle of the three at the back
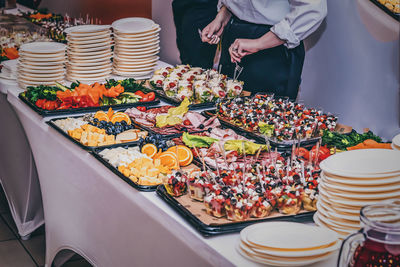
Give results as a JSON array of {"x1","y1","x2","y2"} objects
[{"x1": 65, "y1": 25, "x2": 113, "y2": 82}]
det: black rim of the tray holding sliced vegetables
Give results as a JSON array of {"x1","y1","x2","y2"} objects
[{"x1": 18, "y1": 92, "x2": 160, "y2": 117}]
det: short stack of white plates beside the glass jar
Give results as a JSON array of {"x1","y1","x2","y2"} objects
[{"x1": 237, "y1": 222, "x2": 340, "y2": 266}]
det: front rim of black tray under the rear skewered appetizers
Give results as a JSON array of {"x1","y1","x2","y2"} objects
[{"x1": 201, "y1": 110, "x2": 319, "y2": 152}]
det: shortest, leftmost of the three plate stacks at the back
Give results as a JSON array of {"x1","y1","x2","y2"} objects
[{"x1": 17, "y1": 42, "x2": 65, "y2": 88}]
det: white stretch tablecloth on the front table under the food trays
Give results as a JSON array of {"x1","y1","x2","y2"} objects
[{"x1": 0, "y1": 62, "x2": 337, "y2": 266}]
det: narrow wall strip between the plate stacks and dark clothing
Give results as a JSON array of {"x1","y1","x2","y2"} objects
[{"x1": 152, "y1": 0, "x2": 180, "y2": 64}]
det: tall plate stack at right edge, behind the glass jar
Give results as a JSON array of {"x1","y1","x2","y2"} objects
[{"x1": 314, "y1": 149, "x2": 400, "y2": 238}]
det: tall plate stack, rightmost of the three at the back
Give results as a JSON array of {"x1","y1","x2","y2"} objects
[{"x1": 111, "y1": 18, "x2": 160, "y2": 78}]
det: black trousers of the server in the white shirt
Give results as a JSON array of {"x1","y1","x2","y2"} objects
[{"x1": 220, "y1": 17, "x2": 305, "y2": 100}]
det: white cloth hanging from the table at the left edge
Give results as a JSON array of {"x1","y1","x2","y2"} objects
[{"x1": 0, "y1": 79, "x2": 44, "y2": 237}]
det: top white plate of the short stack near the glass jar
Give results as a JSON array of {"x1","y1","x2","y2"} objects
[{"x1": 240, "y1": 222, "x2": 337, "y2": 250}]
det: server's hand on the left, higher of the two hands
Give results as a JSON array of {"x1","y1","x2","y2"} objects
[{"x1": 201, "y1": 6, "x2": 232, "y2": 44}]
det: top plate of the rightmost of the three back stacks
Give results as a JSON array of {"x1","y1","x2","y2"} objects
[{"x1": 111, "y1": 17, "x2": 155, "y2": 33}]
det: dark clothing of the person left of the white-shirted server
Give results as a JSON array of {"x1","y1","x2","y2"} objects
[{"x1": 172, "y1": 0, "x2": 218, "y2": 69}]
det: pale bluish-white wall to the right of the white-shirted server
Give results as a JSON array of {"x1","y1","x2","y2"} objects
[{"x1": 299, "y1": 0, "x2": 400, "y2": 140}]
